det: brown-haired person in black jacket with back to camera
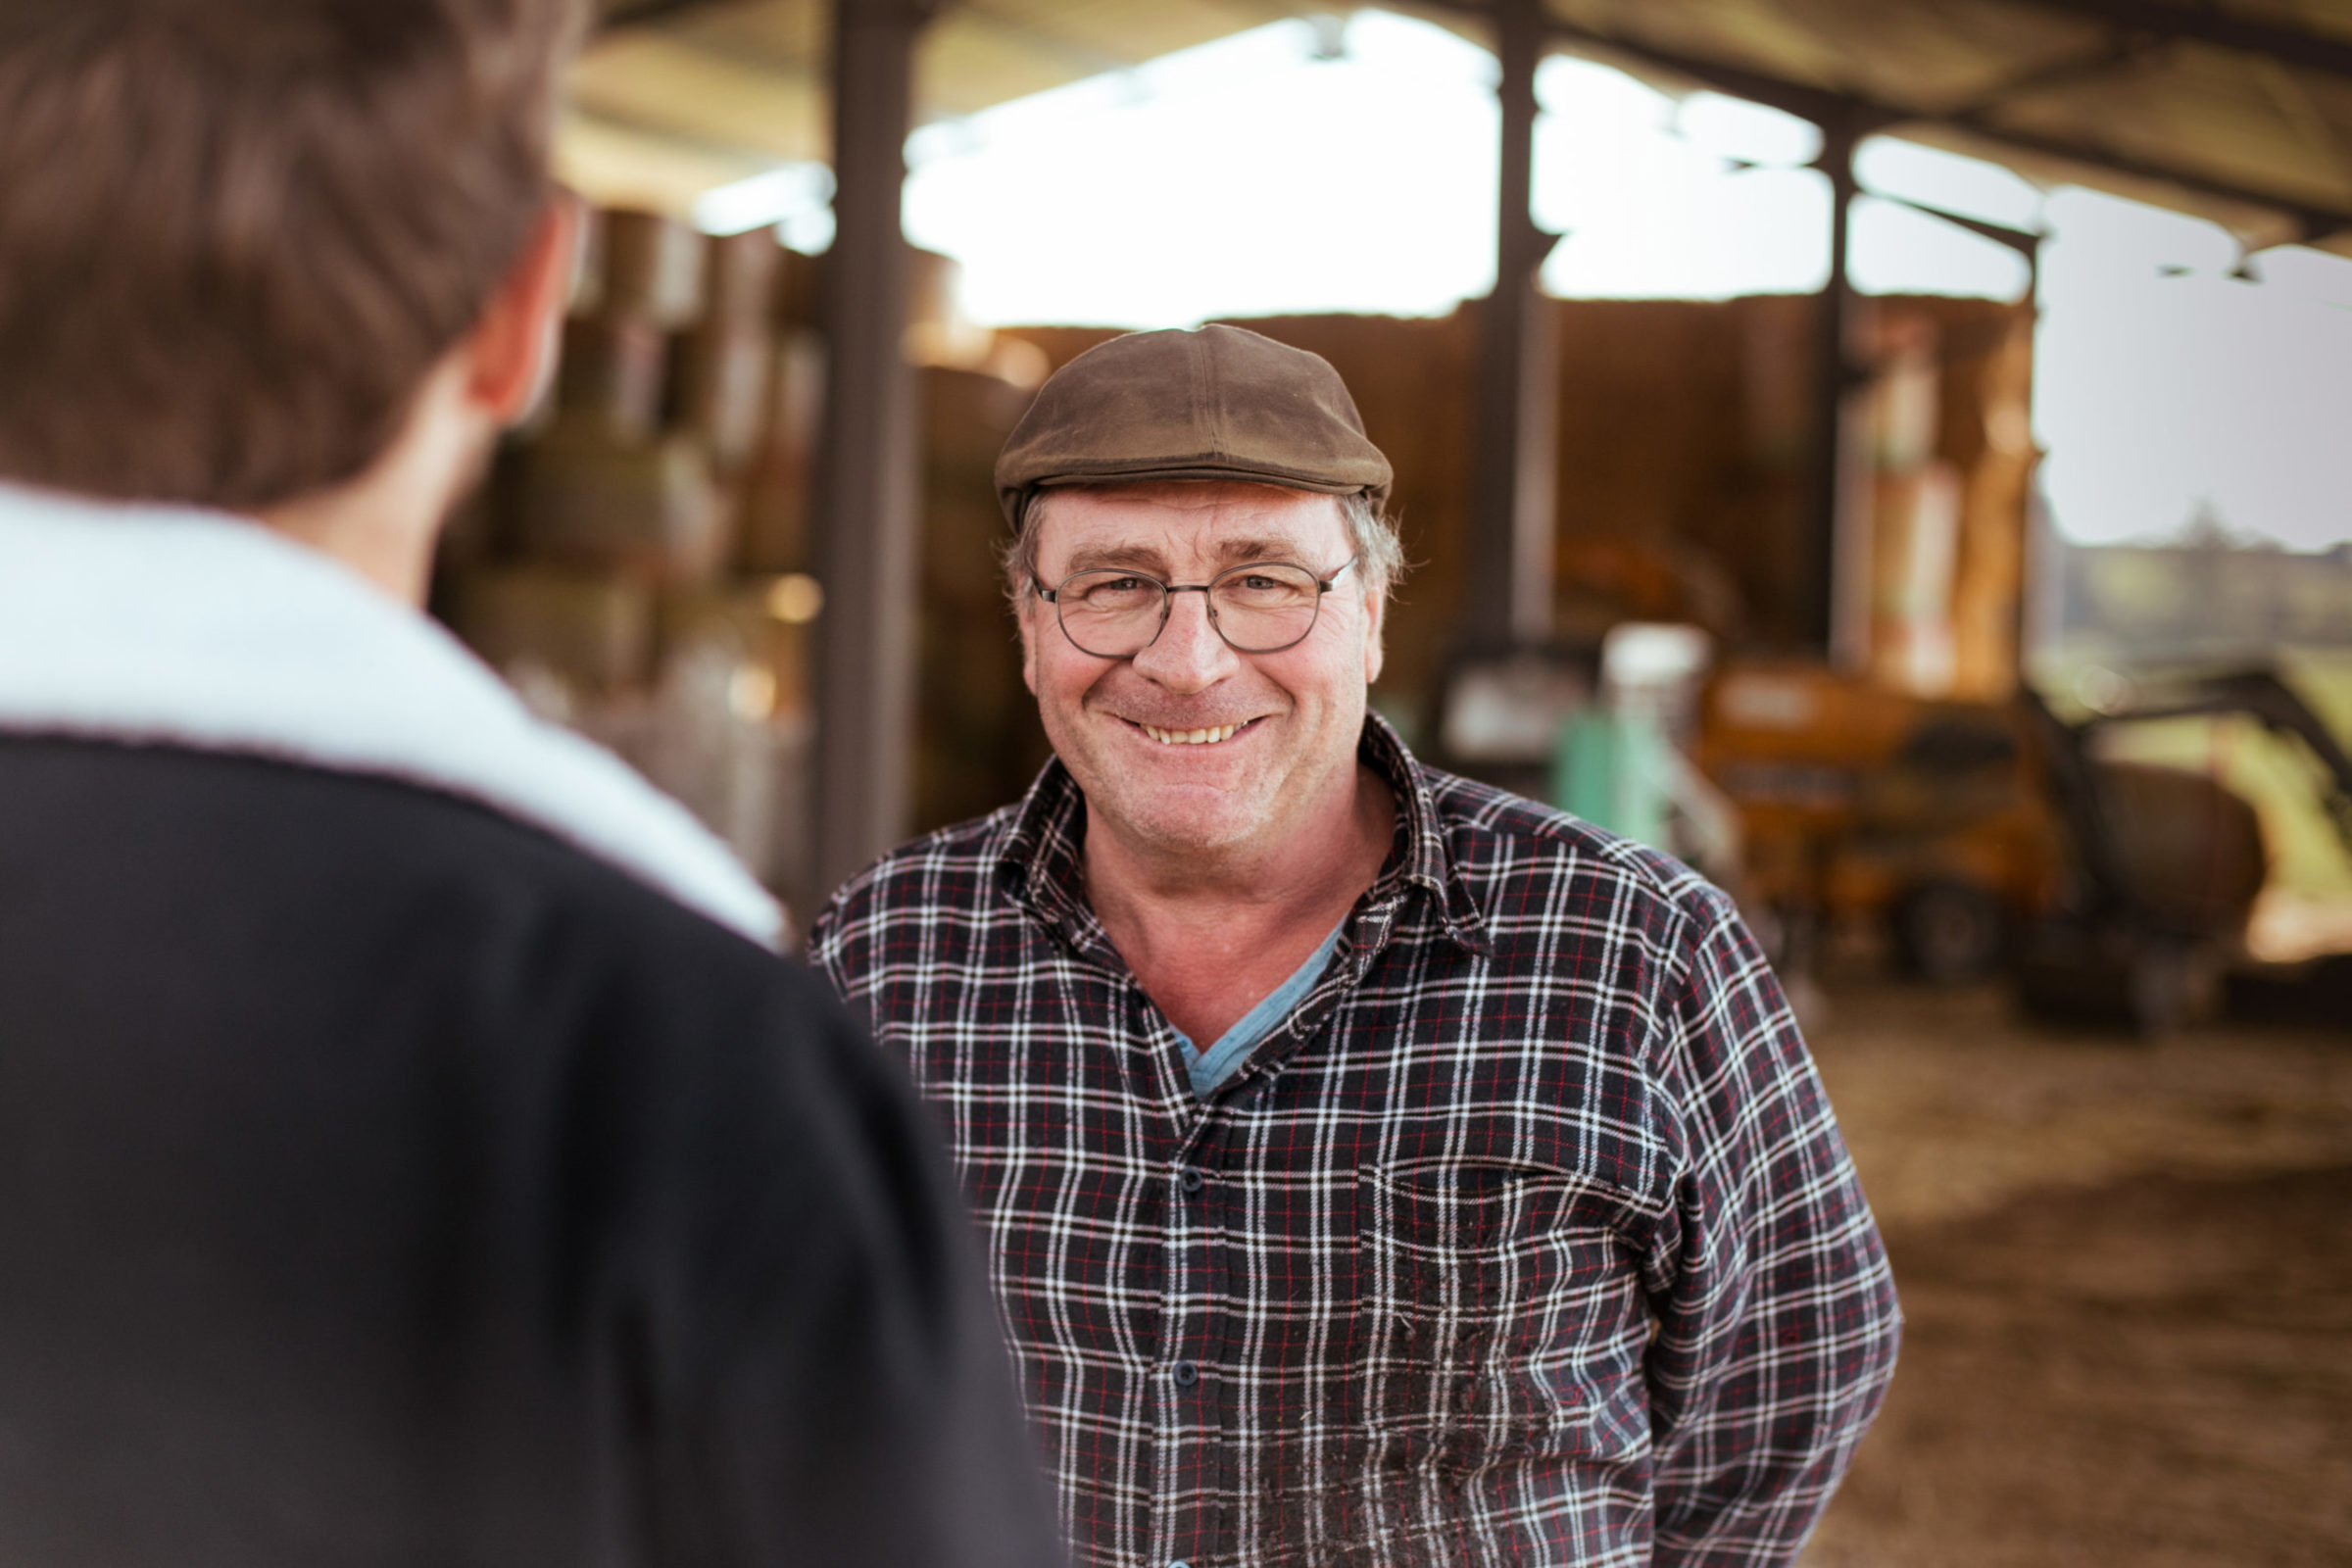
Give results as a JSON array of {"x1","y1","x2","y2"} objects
[{"x1": 0, "y1": 0, "x2": 1060, "y2": 1568}]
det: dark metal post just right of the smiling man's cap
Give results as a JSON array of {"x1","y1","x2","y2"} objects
[{"x1": 1463, "y1": 0, "x2": 1559, "y2": 647}]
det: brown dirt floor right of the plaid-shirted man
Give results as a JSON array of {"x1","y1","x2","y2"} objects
[{"x1": 1801, "y1": 983, "x2": 2352, "y2": 1568}]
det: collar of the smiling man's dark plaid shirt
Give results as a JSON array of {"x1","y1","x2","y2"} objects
[{"x1": 993, "y1": 712, "x2": 1492, "y2": 955}]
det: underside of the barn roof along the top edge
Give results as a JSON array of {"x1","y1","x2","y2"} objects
[{"x1": 564, "y1": 0, "x2": 2352, "y2": 252}]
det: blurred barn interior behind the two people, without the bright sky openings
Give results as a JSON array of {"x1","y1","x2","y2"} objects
[{"x1": 435, "y1": 0, "x2": 2352, "y2": 1566}]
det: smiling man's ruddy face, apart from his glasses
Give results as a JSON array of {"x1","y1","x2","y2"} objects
[{"x1": 1021, "y1": 482, "x2": 1381, "y2": 851}]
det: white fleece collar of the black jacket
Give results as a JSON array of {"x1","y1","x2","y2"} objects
[{"x1": 0, "y1": 484, "x2": 783, "y2": 948}]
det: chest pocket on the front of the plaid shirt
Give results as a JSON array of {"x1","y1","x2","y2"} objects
[{"x1": 1357, "y1": 1163, "x2": 1646, "y2": 1469}]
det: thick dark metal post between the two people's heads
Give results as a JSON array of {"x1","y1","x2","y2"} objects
[{"x1": 798, "y1": 0, "x2": 929, "y2": 917}]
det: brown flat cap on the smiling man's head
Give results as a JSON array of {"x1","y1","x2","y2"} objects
[{"x1": 998, "y1": 326, "x2": 1393, "y2": 522}]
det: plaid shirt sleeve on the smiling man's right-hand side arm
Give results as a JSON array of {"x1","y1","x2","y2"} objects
[{"x1": 1646, "y1": 896, "x2": 1900, "y2": 1568}]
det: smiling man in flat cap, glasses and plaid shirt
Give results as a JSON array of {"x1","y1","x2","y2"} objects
[{"x1": 813, "y1": 326, "x2": 1898, "y2": 1568}]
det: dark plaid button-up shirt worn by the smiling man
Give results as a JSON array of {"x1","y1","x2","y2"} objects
[{"x1": 811, "y1": 717, "x2": 1898, "y2": 1568}]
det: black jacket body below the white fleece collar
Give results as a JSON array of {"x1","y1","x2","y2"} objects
[{"x1": 0, "y1": 496, "x2": 1056, "y2": 1568}]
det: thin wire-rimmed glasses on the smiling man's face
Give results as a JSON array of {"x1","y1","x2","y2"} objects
[{"x1": 1030, "y1": 555, "x2": 1364, "y2": 659}]
